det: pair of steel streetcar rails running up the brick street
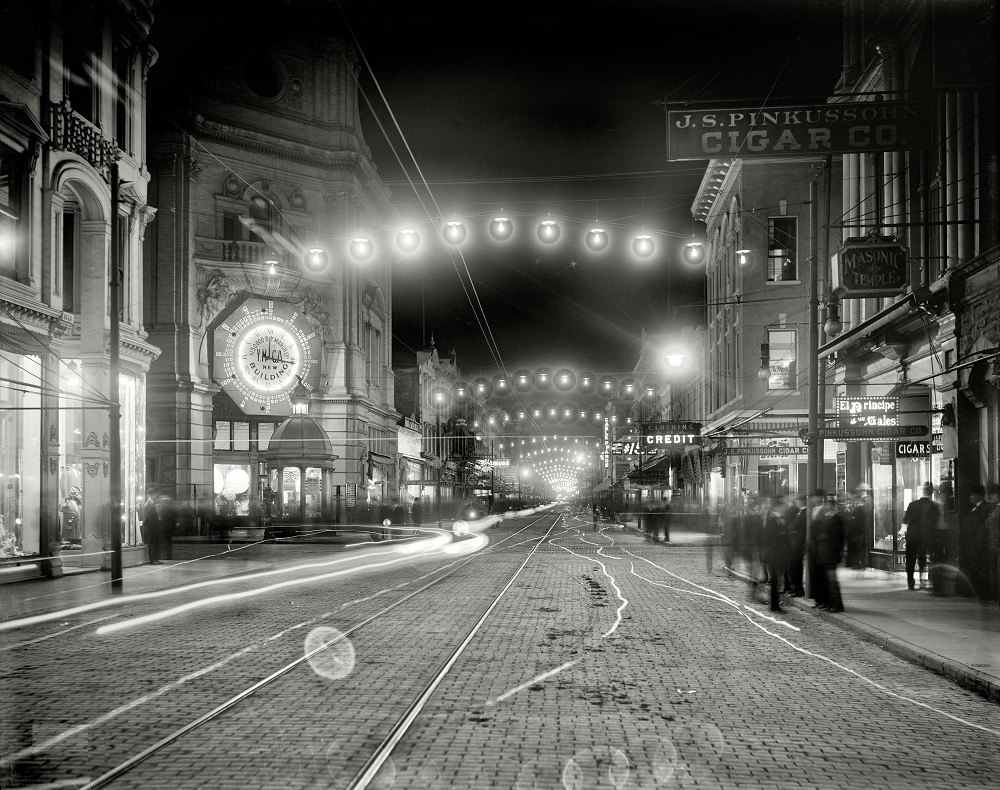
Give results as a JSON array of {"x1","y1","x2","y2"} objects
[{"x1": 67, "y1": 513, "x2": 561, "y2": 790}]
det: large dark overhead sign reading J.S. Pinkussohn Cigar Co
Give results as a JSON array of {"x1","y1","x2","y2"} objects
[{"x1": 667, "y1": 101, "x2": 933, "y2": 162}]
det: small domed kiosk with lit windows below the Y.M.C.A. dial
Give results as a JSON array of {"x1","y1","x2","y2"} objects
[{"x1": 262, "y1": 384, "x2": 338, "y2": 528}]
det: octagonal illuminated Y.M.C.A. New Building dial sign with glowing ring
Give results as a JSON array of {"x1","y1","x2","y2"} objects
[{"x1": 210, "y1": 297, "x2": 320, "y2": 415}]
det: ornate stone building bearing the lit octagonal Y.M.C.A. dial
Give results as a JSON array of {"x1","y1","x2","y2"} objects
[{"x1": 146, "y1": 12, "x2": 399, "y2": 533}]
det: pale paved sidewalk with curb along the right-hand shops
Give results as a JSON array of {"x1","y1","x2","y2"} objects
[{"x1": 726, "y1": 562, "x2": 1000, "y2": 702}]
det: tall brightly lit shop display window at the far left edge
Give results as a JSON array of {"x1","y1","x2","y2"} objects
[{"x1": 0, "y1": 350, "x2": 41, "y2": 557}]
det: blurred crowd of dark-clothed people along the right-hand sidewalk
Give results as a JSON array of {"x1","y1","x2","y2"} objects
[{"x1": 721, "y1": 483, "x2": 1000, "y2": 612}]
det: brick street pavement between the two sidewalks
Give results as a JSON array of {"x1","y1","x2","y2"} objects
[{"x1": 0, "y1": 512, "x2": 1000, "y2": 788}]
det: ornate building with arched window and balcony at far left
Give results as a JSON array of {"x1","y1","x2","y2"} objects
[{"x1": 0, "y1": 0, "x2": 159, "y2": 573}]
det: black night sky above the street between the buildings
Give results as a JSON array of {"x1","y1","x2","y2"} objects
[{"x1": 152, "y1": 0, "x2": 842, "y2": 378}]
